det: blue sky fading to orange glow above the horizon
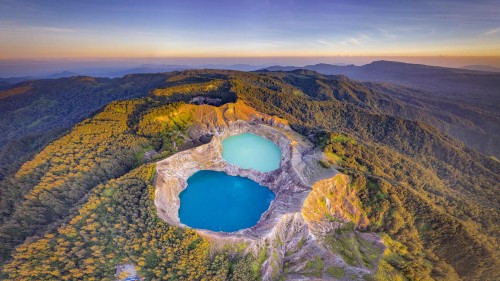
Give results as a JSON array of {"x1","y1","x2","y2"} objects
[{"x1": 0, "y1": 0, "x2": 500, "y2": 59}]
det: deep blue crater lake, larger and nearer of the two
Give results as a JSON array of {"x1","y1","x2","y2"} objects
[{"x1": 179, "y1": 171, "x2": 275, "y2": 232}]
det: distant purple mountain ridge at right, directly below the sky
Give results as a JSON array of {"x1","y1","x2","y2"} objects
[{"x1": 263, "y1": 61, "x2": 500, "y2": 109}]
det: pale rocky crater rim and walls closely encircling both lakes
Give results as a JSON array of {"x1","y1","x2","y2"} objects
[{"x1": 155, "y1": 120, "x2": 336, "y2": 239}]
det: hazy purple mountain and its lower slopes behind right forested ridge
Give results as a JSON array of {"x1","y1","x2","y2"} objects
[{"x1": 266, "y1": 61, "x2": 500, "y2": 157}]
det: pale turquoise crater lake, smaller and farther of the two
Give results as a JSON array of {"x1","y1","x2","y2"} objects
[{"x1": 222, "y1": 133, "x2": 281, "y2": 172}]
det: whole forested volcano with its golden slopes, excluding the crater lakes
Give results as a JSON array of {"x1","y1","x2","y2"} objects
[{"x1": 0, "y1": 66, "x2": 500, "y2": 280}]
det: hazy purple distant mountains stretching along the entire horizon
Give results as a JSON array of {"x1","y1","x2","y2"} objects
[{"x1": 0, "y1": 61, "x2": 500, "y2": 155}]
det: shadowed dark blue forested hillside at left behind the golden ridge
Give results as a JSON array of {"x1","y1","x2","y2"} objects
[{"x1": 0, "y1": 74, "x2": 168, "y2": 179}]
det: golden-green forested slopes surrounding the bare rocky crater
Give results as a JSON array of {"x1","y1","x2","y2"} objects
[{"x1": 0, "y1": 70, "x2": 500, "y2": 280}]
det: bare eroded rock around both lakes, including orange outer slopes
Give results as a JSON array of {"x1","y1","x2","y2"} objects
[{"x1": 155, "y1": 102, "x2": 383, "y2": 280}]
